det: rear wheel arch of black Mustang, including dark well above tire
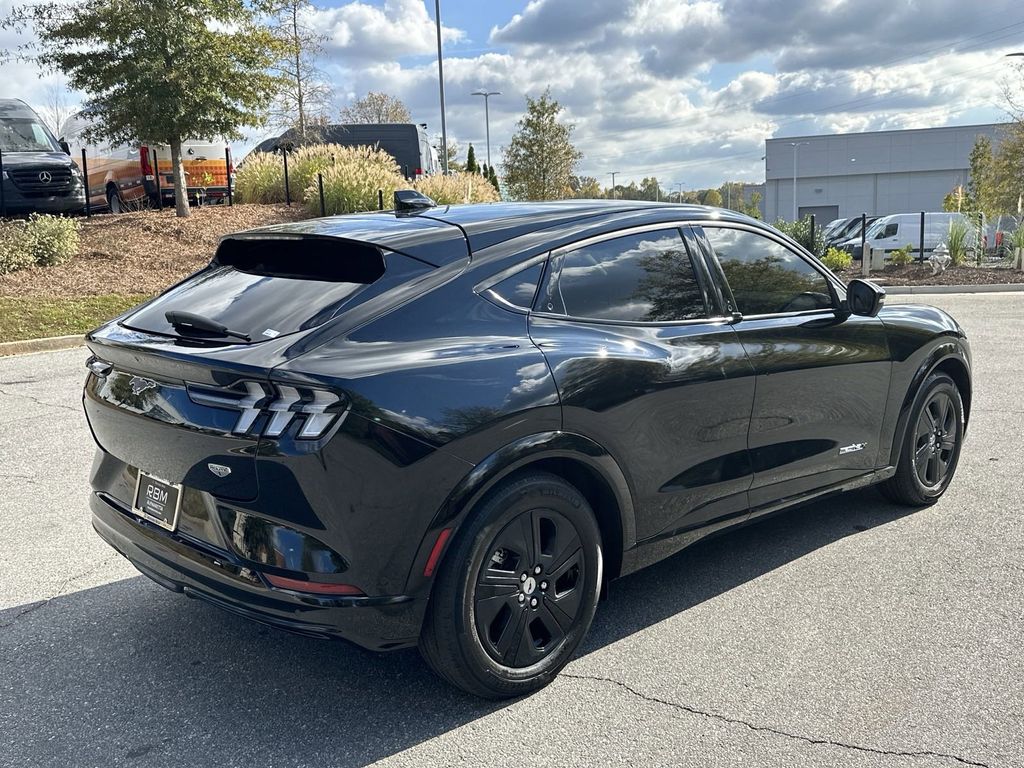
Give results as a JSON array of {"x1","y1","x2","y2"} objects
[{"x1": 407, "y1": 431, "x2": 636, "y2": 594}]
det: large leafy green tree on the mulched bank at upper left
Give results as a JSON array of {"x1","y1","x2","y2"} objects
[{"x1": 4, "y1": 0, "x2": 280, "y2": 216}]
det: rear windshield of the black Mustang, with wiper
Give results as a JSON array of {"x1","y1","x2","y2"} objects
[{"x1": 124, "y1": 238, "x2": 385, "y2": 343}]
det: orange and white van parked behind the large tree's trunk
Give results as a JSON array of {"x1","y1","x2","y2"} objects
[{"x1": 61, "y1": 112, "x2": 233, "y2": 213}]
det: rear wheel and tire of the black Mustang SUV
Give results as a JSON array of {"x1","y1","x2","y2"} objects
[{"x1": 420, "y1": 472, "x2": 603, "y2": 699}]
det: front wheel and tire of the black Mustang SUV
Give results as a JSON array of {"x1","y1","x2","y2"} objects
[{"x1": 879, "y1": 374, "x2": 964, "y2": 507}]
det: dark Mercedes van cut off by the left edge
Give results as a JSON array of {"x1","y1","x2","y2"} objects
[{"x1": 0, "y1": 98, "x2": 85, "y2": 216}]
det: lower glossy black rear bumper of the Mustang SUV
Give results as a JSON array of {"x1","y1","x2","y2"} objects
[{"x1": 90, "y1": 493, "x2": 426, "y2": 650}]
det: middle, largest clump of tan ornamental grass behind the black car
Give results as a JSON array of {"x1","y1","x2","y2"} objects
[{"x1": 304, "y1": 146, "x2": 407, "y2": 215}]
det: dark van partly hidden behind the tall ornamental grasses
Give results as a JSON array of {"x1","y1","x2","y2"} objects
[{"x1": 253, "y1": 123, "x2": 441, "y2": 180}]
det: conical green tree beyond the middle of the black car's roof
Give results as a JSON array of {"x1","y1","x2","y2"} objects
[{"x1": 504, "y1": 88, "x2": 583, "y2": 200}]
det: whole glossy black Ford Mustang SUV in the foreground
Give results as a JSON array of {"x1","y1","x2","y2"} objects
[{"x1": 84, "y1": 201, "x2": 972, "y2": 698}]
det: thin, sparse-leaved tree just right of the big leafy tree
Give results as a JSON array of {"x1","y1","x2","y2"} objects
[{"x1": 268, "y1": 0, "x2": 331, "y2": 139}]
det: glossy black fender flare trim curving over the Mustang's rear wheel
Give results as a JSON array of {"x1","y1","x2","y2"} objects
[{"x1": 407, "y1": 431, "x2": 636, "y2": 595}]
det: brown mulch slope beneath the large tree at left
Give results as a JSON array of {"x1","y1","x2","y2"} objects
[{"x1": 0, "y1": 205, "x2": 308, "y2": 297}]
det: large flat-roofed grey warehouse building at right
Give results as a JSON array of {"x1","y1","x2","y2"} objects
[{"x1": 763, "y1": 124, "x2": 1001, "y2": 223}]
